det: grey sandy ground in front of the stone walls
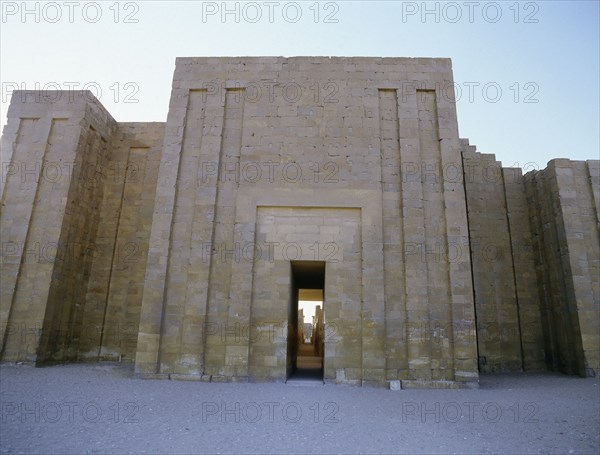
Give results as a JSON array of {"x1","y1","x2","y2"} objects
[{"x1": 0, "y1": 364, "x2": 600, "y2": 454}]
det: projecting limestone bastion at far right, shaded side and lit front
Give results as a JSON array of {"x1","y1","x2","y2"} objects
[{"x1": 525, "y1": 159, "x2": 600, "y2": 376}]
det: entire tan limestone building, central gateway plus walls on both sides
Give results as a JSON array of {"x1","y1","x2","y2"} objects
[{"x1": 0, "y1": 57, "x2": 600, "y2": 388}]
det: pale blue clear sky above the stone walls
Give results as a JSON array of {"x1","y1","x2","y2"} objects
[{"x1": 0, "y1": 1, "x2": 600, "y2": 169}]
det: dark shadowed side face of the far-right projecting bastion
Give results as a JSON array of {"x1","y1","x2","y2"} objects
[{"x1": 525, "y1": 160, "x2": 585, "y2": 375}]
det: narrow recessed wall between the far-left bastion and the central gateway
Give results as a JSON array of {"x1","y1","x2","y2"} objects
[{"x1": 77, "y1": 123, "x2": 164, "y2": 362}]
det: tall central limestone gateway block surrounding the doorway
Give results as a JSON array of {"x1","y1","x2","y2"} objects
[{"x1": 136, "y1": 57, "x2": 477, "y2": 384}]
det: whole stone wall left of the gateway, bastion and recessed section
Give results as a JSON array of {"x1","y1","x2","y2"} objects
[{"x1": 0, "y1": 91, "x2": 164, "y2": 364}]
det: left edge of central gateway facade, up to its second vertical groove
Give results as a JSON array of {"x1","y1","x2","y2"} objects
[{"x1": 136, "y1": 82, "x2": 224, "y2": 377}]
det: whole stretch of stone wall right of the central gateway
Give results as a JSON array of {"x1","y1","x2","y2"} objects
[{"x1": 462, "y1": 140, "x2": 600, "y2": 376}]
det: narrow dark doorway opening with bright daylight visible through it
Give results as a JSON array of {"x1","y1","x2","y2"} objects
[{"x1": 287, "y1": 261, "x2": 325, "y2": 382}]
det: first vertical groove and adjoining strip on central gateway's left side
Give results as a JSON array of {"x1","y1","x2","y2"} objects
[{"x1": 160, "y1": 90, "x2": 224, "y2": 376}]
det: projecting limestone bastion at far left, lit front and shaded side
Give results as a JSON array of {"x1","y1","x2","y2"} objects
[{"x1": 0, "y1": 91, "x2": 116, "y2": 362}]
